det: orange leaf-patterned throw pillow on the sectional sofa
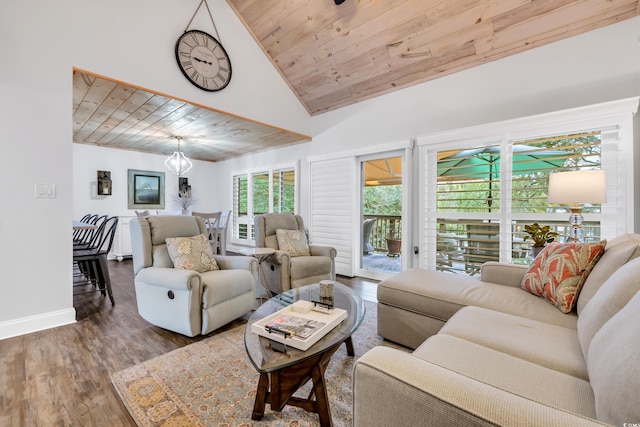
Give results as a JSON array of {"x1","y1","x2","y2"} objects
[{"x1": 520, "y1": 240, "x2": 607, "y2": 313}]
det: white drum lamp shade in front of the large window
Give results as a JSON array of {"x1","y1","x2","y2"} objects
[{"x1": 548, "y1": 169, "x2": 607, "y2": 204}]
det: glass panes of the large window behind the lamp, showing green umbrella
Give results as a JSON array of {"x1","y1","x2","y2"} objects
[{"x1": 436, "y1": 131, "x2": 601, "y2": 274}]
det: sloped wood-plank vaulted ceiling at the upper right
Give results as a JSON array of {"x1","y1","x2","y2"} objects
[{"x1": 228, "y1": 0, "x2": 640, "y2": 115}]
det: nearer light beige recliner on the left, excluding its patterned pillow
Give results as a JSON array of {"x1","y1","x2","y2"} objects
[{"x1": 130, "y1": 216, "x2": 258, "y2": 337}]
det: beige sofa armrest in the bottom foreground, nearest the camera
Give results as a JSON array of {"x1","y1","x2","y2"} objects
[{"x1": 353, "y1": 347, "x2": 606, "y2": 427}]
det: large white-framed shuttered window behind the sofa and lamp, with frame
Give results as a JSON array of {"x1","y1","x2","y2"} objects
[{"x1": 419, "y1": 99, "x2": 638, "y2": 275}]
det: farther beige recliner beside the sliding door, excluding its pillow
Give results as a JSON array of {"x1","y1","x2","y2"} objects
[{"x1": 254, "y1": 213, "x2": 336, "y2": 293}]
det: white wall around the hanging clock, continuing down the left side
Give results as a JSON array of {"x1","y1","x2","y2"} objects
[{"x1": 0, "y1": 0, "x2": 311, "y2": 339}]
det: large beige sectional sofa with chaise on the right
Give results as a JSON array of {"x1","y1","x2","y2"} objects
[{"x1": 353, "y1": 234, "x2": 640, "y2": 427}]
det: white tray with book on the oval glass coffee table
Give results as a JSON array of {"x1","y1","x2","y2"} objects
[{"x1": 251, "y1": 307, "x2": 347, "y2": 351}]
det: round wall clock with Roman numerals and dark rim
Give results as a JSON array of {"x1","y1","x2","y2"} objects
[{"x1": 176, "y1": 30, "x2": 231, "y2": 92}]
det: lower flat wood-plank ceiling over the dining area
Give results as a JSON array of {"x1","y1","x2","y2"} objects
[{"x1": 73, "y1": 70, "x2": 311, "y2": 162}]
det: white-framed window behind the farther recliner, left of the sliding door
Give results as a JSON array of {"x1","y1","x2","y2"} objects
[{"x1": 232, "y1": 166, "x2": 297, "y2": 244}]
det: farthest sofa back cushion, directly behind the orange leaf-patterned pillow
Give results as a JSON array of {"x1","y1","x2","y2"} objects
[{"x1": 576, "y1": 233, "x2": 640, "y2": 315}]
